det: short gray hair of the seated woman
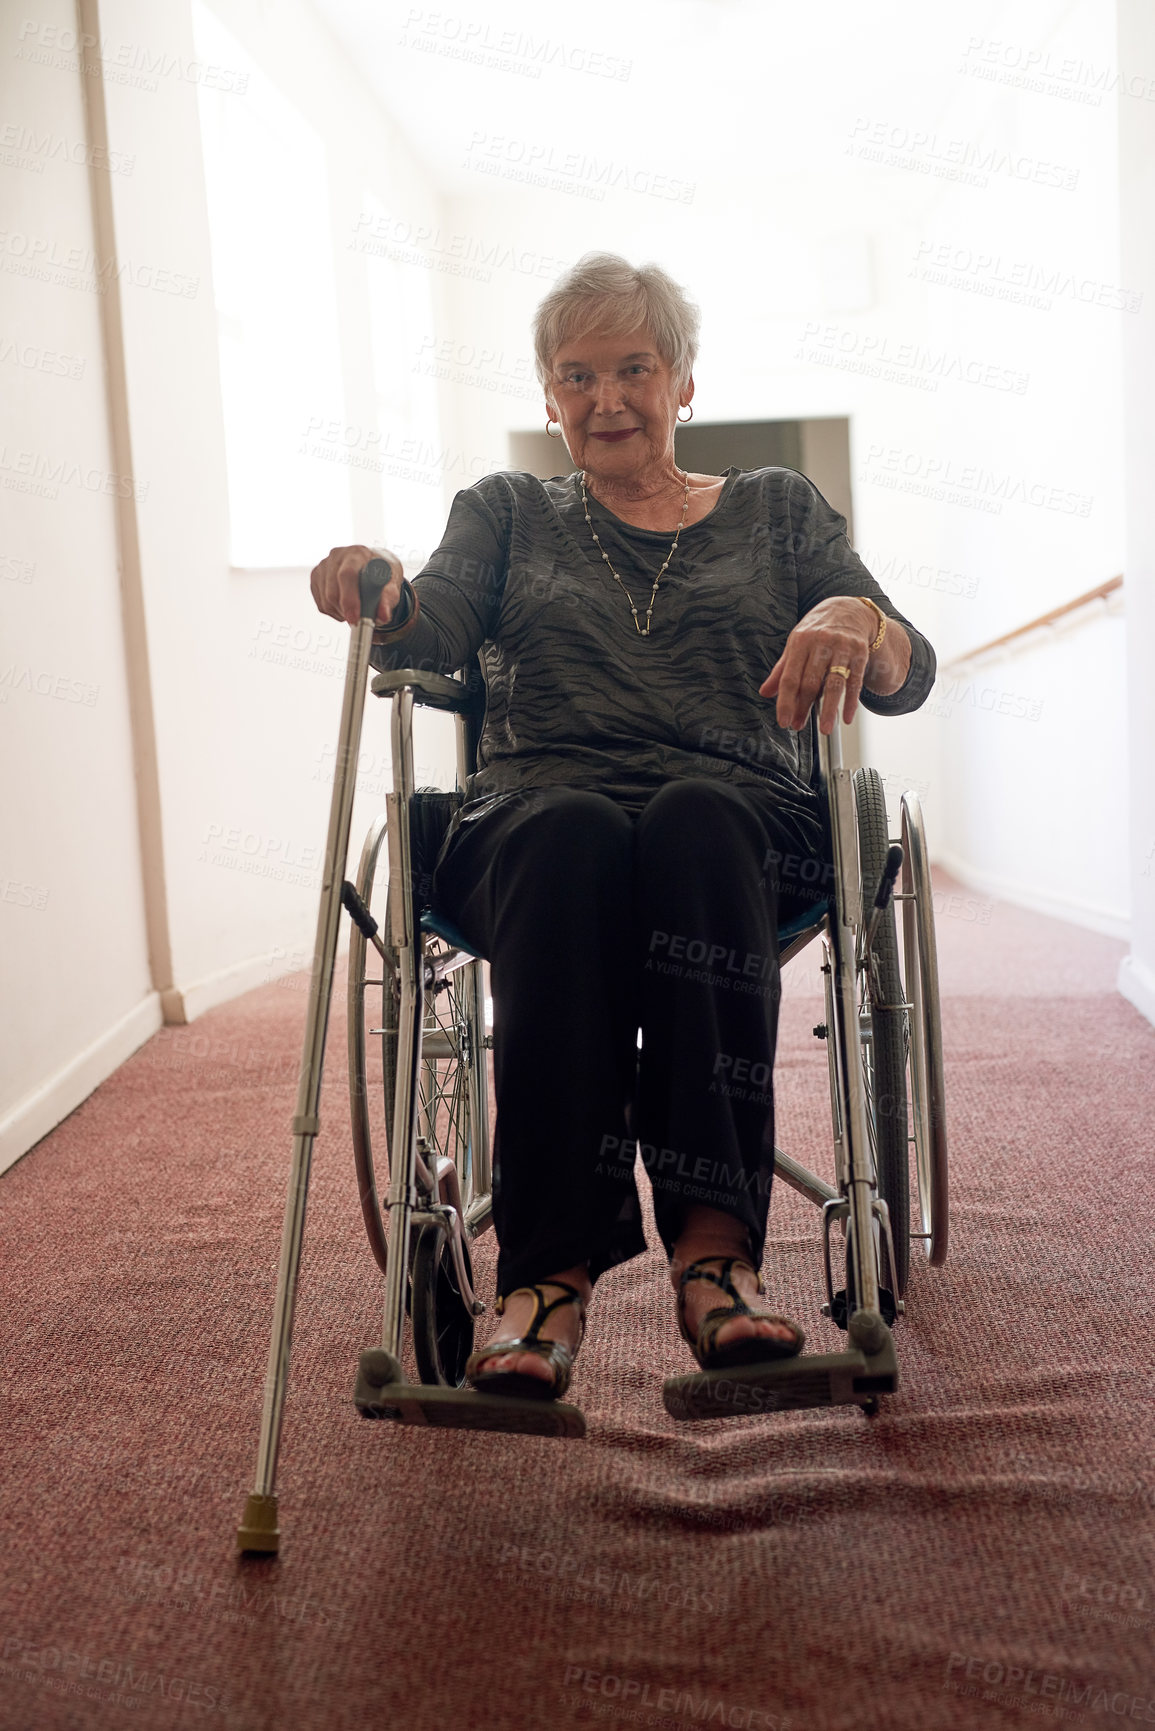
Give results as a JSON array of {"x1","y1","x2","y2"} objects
[{"x1": 532, "y1": 253, "x2": 701, "y2": 389}]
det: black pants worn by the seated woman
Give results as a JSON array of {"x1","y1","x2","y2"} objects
[{"x1": 435, "y1": 777, "x2": 817, "y2": 1293}]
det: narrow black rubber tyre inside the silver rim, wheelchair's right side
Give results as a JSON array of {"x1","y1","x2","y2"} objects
[{"x1": 854, "y1": 769, "x2": 911, "y2": 1298}]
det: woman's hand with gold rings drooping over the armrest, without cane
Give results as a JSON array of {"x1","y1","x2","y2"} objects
[{"x1": 758, "y1": 595, "x2": 878, "y2": 734}]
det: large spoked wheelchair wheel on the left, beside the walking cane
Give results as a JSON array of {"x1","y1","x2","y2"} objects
[{"x1": 348, "y1": 815, "x2": 485, "y2": 1276}]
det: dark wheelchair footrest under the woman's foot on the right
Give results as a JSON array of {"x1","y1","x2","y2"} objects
[{"x1": 661, "y1": 1335, "x2": 899, "y2": 1419}]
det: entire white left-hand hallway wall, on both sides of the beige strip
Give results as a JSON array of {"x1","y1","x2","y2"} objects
[{"x1": 0, "y1": 0, "x2": 454, "y2": 1158}]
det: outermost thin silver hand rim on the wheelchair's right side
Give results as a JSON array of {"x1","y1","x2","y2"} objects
[{"x1": 902, "y1": 791, "x2": 949, "y2": 1265}]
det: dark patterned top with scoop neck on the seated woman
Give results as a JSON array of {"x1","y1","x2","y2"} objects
[{"x1": 372, "y1": 469, "x2": 935, "y2": 852}]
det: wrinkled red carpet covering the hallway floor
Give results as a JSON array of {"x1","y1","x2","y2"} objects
[{"x1": 0, "y1": 881, "x2": 1155, "y2": 1731}]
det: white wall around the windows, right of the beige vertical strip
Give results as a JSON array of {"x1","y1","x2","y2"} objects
[{"x1": 98, "y1": 0, "x2": 460, "y2": 1013}]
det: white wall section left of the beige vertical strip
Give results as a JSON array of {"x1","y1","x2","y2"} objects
[{"x1": 0, "y1": 0, "x2": 161, "y2": 1168}]
